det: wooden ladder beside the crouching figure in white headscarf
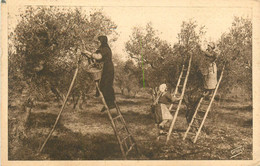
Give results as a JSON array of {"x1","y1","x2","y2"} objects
[{"x1": 166, "y1": 53, "x2": 192, "y2": 144}]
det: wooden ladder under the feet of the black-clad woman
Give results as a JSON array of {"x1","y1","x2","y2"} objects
[{"x1": 95, "y1": 81, "x2": 139, "y2": 159}]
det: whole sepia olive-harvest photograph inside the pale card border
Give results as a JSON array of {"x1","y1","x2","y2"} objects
[{"x1": 1, "y1": 0, "x2": 260, "y2": 165}]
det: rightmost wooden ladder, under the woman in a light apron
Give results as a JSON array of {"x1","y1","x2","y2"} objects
[{"x1": 183, "y1": 64, "x2": 225, "y2": 143}]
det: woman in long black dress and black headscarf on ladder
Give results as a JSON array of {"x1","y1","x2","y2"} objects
[{"x1": 96, "y1": 36, "x2": 115, "y2": 112}]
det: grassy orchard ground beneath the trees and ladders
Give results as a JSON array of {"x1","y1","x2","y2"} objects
[{"x1": 8, "y1": 92, "x2": 253, "y2": 160}]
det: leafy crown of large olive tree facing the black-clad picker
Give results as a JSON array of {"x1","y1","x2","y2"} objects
[{"x1": 9, "y1": 7, "x2": 117, "y2": 105}]
